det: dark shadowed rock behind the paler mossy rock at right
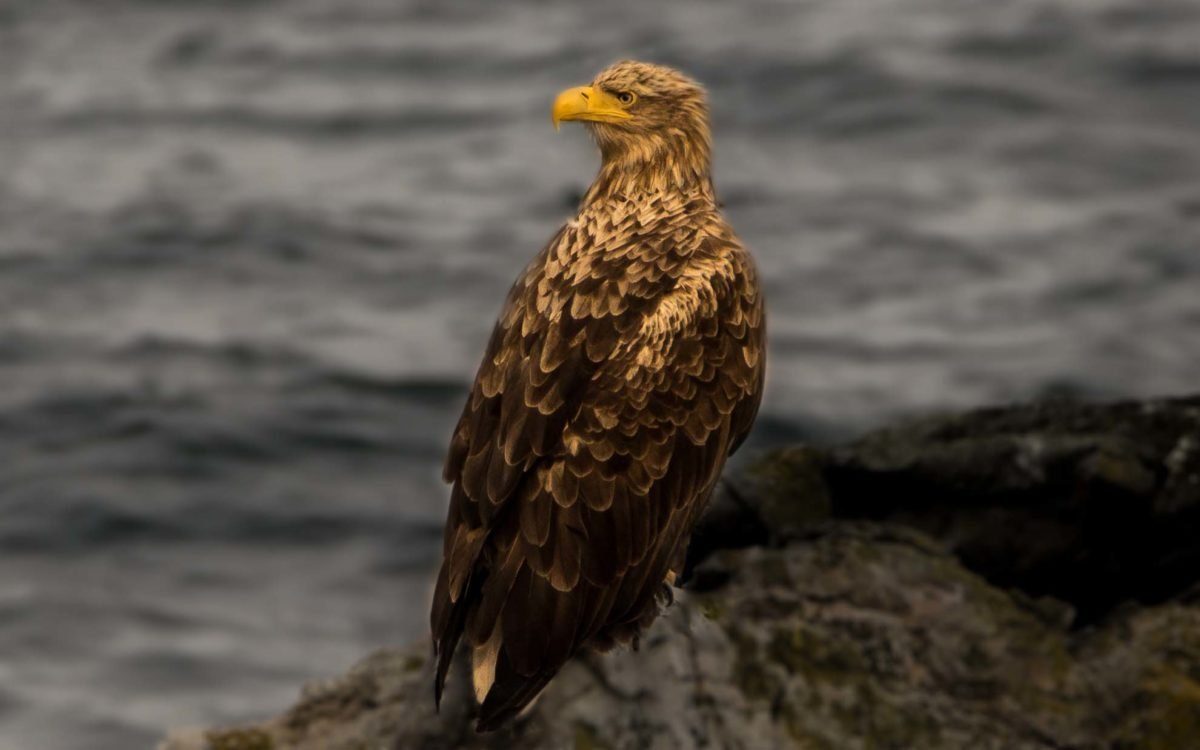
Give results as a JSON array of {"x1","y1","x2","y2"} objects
[{"x1": 734, "y1": 397, "x2": 1200, "y2": 624}]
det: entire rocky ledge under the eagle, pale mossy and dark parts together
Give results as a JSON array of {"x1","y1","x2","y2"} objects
[{"x1": 161, "y1": 397, "x2": 1200, "y2": 750}]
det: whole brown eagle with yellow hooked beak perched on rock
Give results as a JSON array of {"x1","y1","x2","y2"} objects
[{"x1": 430, "y1": 60, "x2": 766, "y2": 732}]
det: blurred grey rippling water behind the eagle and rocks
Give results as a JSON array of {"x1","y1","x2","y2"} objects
[{"x1": 7, "y1": 0, "x2": 1200, "y2": 749}]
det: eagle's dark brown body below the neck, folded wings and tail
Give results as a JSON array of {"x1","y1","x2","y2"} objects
[{"x1": 431, "y1": 234, "x2": 764, "y2": 728}]
